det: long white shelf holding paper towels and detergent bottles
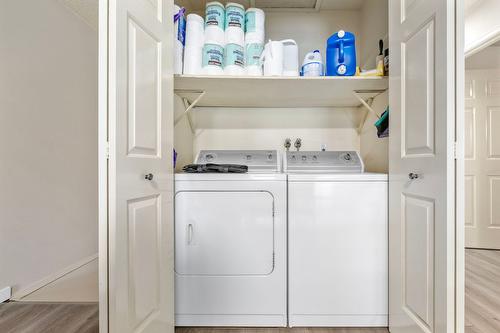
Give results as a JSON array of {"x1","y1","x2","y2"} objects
[{"x1": 174, "y1": 75, "x2": 389, "y2": 108}]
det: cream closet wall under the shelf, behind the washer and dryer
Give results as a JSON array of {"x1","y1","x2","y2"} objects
[{"x1": 175, "y1": 107, "x2": 362, "y2": 164}]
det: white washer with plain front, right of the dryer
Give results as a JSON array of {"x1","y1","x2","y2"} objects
[{"x1": 284, "y1": 151, "x2": 388, "y2": 327}]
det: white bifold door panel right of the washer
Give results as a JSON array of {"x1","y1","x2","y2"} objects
[{"x1": 389, "y1": 0, "x2": 463, "y2": 333}]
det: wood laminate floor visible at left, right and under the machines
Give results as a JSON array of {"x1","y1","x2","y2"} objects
[{"x1": 0, "y1": 249, "x2": 500, "y2": 333}]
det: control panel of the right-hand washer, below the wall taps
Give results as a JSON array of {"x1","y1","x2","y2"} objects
[{"x1": 284, "y1": 151, "x2": 364, "y2": 173}]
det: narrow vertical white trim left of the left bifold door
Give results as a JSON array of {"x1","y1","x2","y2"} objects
[{"x1": 98, "y1": 0, "x2": 110, "y2": 333}]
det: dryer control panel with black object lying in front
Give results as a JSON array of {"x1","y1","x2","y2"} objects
[{"x1": 195, "y1": 150, "x2": 280, "y2": 172}]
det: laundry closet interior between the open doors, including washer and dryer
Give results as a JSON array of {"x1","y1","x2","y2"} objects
[{"x1": 174, "y1": 0, "x2": 389, "y2": 327}]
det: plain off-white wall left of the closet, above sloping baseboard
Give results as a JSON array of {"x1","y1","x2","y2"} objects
[{"x1": 0, "y1": 0, "x2": 97, "y2": 296}]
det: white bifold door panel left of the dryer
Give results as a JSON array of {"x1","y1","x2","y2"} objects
[{"x1": 103, "y1": 0, "x2": 174, "y2": 333}]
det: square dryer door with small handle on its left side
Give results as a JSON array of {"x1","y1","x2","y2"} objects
[{"x1": 175, "y1": 191, "x2": 274, "y2": 276}]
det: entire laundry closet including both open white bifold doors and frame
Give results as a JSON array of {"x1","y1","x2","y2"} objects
[{"x1": 99, "y1": 0, "x2": 463, "y2": 332}]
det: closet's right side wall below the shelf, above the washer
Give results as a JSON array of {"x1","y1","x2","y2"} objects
[{"x1": 360, "y1": 91, "x2": 390, "y2": 173}]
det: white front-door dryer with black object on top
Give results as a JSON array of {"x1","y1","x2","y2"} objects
[{"x1": 175, "y1": 151, "x2": 287, "y2": 326}]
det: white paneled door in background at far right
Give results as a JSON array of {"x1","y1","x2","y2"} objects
[{"x1": 465, "y1": 70, "x2": 500, "y2": 250}]
